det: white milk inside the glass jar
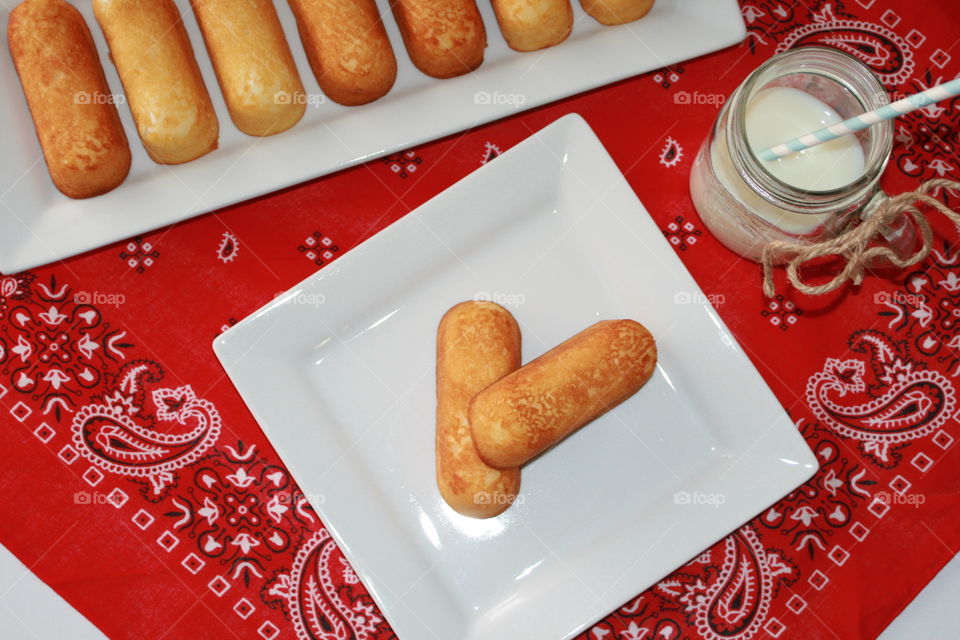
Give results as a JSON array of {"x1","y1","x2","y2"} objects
[{"x1": 691, "y1": 87, "x2": 865, "y2": 260}]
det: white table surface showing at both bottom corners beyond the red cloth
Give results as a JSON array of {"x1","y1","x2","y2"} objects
[{"x1": 0, "y1": 546, "x2": 960, "y2": 640}]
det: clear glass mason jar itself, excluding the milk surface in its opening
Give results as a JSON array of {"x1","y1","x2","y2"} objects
[{"x1": 690, "y1": 46, "x2": 914, "y2": 261}]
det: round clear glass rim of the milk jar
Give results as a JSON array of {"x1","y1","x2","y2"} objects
[{"x1": 726, "y1": 45, "x2": 893, "y2": 214}]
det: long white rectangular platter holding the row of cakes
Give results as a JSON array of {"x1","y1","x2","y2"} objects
[{"x1": 0, "y1": 0, "x2": 746, "y2": 273}]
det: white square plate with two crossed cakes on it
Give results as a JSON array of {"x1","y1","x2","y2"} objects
[{"x1": 214, "y1": 115, "x2": 817, "y2": 640}]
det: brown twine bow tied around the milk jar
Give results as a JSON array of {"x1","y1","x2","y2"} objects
[{"x1": 761, "y1": 178, "x2": 960, "y2": 298}]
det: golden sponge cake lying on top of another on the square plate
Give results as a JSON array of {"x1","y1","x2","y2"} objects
[{"x1": 470, "y1": 320, "x2": 657, "y2": 469}]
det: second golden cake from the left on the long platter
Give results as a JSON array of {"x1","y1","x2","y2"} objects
[{"x1": 93, "y1": 0, "x2": 219, "y2": 164}]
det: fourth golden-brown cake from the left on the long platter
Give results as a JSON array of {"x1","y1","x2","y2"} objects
[{"x1": 290, "y1": 0, "x2": 397, "y2": 106}]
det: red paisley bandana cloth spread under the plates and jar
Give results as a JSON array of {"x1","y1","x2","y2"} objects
[{"x1": 0, "y1": 0, "x2": 960, "y2": 640}]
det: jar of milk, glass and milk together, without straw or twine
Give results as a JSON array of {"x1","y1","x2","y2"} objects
[{"x1": 690, "y1": 47, "x2": 892, "y2": 261}]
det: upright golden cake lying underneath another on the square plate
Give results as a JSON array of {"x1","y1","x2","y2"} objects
[{"x1": 436, "y1": 302, "x2": 520, "y2": 518}]
